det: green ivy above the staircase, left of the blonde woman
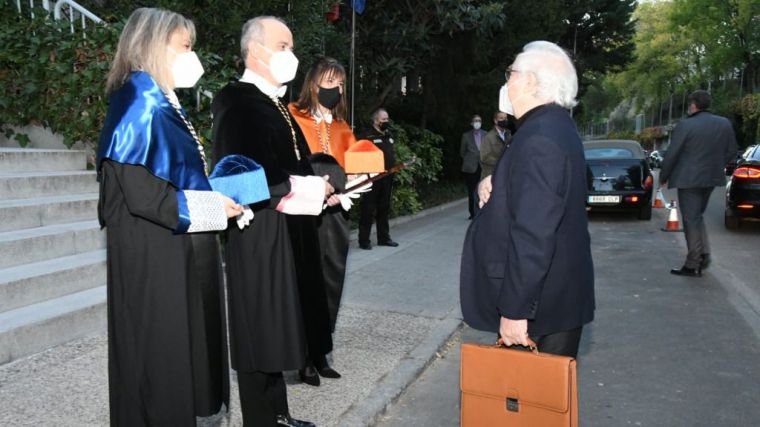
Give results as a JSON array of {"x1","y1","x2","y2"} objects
[{"x1": 0, "y1": 2, "x2": 120, "y2": 146}]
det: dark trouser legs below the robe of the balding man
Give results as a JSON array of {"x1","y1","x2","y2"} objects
[{"x1": 238, "y1": 371, "x2": 288, "y2": 427}]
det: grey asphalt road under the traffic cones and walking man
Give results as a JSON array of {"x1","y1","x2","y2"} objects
[{"x1": 377, "y1": 172, "x2": 760, "y2": 427}]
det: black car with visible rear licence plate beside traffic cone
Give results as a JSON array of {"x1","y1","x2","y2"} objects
[{"x1": 583, "y1": 140, "x2": 654, "y2": 220}]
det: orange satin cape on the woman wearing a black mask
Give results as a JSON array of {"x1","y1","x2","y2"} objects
[{"x1": 288, "y1": 103, "x2": 356, "y2": 170}]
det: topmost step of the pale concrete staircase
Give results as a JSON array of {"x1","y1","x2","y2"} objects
[{"x1": 0, "y1": 148, "x2": 87, "y2": 173}]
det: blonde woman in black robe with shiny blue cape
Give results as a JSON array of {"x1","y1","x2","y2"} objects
[{"x1": 97, "y1": 8, "x2": 242, "y2": 427}]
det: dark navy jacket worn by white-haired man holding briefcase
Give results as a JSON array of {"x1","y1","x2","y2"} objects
[{"x1": 460, "y1": 104, "x2": 594, "y2": 336}]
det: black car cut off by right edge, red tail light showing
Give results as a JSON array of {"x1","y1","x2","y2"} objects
[{"x1": 724, "y1": 145, "x2": 760, "y2": 229}]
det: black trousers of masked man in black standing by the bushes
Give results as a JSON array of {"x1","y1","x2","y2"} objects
[{"x1": 359, "y1": 176, "x2": 393, "y2": 245}]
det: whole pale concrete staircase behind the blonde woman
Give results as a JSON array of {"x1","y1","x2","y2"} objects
[{"x1": 0, "y1": 148, "x2": 106, "y2": 364}]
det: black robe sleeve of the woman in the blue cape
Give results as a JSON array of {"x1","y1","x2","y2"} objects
[{"x1": 98, "y1": 160, "x2": 179, "y2": 230}]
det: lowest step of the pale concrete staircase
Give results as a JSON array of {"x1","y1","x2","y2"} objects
[{"x1": 0, "y1": 285, "x2": 106, "y2": 364}]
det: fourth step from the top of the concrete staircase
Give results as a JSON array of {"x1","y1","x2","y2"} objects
[{"x1": 0, "y1": 221, "x2": 106, "y2": 268}]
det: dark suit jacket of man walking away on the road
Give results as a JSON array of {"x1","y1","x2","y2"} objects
[{"x1": 660, "y1": 111, "x2": 736, "y2": 188}]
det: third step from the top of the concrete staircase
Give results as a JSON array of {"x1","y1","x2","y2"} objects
[{"x1": 0, "y1": 193, "x2": 98, "y2": 231}]
